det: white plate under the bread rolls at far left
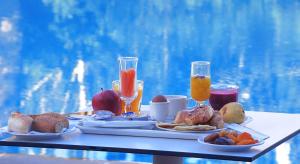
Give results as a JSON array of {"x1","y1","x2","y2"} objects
[{"x1": 2, "y1": 126, "x2": 76, "y2": 140}]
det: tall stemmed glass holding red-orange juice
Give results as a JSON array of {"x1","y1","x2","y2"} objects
[{"x1": 119, "y1": 57, "x2": 138, "y2": 113}]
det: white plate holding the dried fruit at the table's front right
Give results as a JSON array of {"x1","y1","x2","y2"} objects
[{"x1": 198, "y1": 137, "x2": 264, "y2": 151}]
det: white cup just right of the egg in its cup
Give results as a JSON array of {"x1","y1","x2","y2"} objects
[{"x1": 165, "y1": 95, "x2": 188, "y2": 120}]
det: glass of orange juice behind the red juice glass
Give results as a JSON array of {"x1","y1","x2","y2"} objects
[{"x1": 112, "y1": 80, "x2": 144, "y2": 114}]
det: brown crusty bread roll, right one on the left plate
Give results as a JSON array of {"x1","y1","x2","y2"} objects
[{"x1": 32, "y1": 113, "x2": 69, "y2": 133}]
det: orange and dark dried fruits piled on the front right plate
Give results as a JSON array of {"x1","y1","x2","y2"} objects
[{"x1": 204, "y1": 130, "x2": 258, "y2": 145}]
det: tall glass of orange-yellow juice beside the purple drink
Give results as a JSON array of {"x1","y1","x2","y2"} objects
[{"x1": 190, "y1": 61, "x2": 210, "y2": 105}]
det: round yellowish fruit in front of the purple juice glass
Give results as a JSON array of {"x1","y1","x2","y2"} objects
[{"x1": 220, "y1": 102, "x2": 245, "y2": 124}]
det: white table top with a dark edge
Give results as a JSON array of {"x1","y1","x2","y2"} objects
[{"x1": 0, "y1": 111, "x2": 300, "y2": 161}]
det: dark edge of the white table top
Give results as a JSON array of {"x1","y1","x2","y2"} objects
[{"x1": 0, "y1": 111, "x2": 300, "y2": 162}]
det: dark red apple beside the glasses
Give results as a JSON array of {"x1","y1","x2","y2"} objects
[{"x1": 92, "y1": 89, "x2": 122, "y2": 115}]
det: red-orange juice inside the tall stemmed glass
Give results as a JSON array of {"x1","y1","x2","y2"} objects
[{"x1": 121, "y1": 69, "x2": 135, "y2": 97}]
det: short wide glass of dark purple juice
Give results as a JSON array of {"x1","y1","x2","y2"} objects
[{"x1": 209, "y1": 84, "x2": 239, "y2": 110}]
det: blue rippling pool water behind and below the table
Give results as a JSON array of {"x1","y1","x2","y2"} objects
[{"x1": 0, "y1": 0, "x2": 300, "y2": 163}]
